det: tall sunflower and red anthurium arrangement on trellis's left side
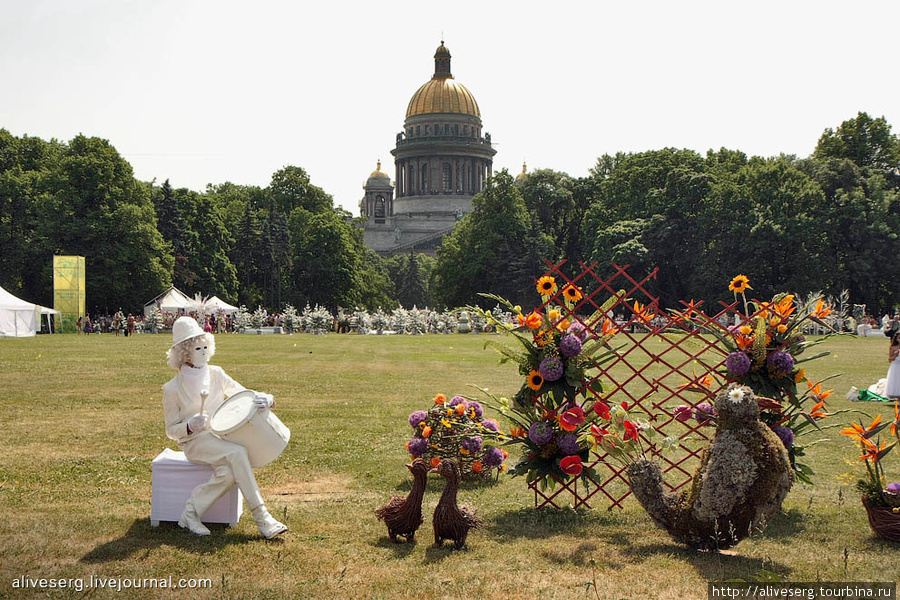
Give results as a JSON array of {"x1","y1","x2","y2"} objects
[{"x1": 467, "y1": 275, "x2": 616, "y2": 489}]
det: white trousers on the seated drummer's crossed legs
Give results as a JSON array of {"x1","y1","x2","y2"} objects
[{"x1": 181, "y1": 431, "x2": 263, "y2": 517}]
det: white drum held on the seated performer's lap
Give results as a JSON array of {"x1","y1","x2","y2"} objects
[{"x1": 209, "y1": 390, "x2": 291, "y2": 469}]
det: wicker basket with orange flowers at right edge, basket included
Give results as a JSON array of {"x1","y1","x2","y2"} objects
[{"x1": 841, "y1": 402, "x2": 900, "y2": 542}]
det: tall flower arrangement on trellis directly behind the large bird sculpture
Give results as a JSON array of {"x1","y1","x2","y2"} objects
[{"x1": 673, "y1": 275, "x2": 844, "y2": 484}]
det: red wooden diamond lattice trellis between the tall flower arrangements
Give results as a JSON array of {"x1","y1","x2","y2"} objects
[{"x1": 529, "y1": 261, "x2": 749, "y2": 508}]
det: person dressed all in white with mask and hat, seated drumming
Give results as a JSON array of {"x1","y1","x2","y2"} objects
[{"x1": 163, "y1": 317, "x2": 287, "y2": 539}]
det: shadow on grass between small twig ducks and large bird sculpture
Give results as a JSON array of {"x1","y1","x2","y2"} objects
[{"x1": 482, "y1": 508, "x2": 615, "y2": 539}]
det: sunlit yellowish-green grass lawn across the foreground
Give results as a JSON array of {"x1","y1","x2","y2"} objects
[{"x1": 0, "y1": 334, "x2": 900, "y2": 600}]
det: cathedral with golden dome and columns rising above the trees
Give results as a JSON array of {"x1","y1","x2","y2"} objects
[{"x1": 359, "y1": 41, "x2": 496, "y2": 255}]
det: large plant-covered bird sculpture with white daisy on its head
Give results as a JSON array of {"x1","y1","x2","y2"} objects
[{"x1": 627, "y1": 386, "x2": 793, "y2": 550}]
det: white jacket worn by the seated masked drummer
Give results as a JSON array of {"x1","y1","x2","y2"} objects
[{"x1": 163, "y1": 365, "x2": 245, "y2": 445}]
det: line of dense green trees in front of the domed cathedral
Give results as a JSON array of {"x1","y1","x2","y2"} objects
[{"x1": 0, "y1": 113, "x2": 900, "y2": 312}]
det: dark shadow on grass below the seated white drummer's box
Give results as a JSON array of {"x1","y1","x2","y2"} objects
[{"x1": 79, "y1": 519, "x2": 266, "y2": 563}]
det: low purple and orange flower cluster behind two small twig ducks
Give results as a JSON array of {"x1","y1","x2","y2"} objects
[{"x1": 406, "y1": 394, "x2": 508, "y2": 479}]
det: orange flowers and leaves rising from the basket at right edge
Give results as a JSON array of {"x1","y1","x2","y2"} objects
[{"x1": 841, "y1": 402, "x2": 900, "y2": 513}]
